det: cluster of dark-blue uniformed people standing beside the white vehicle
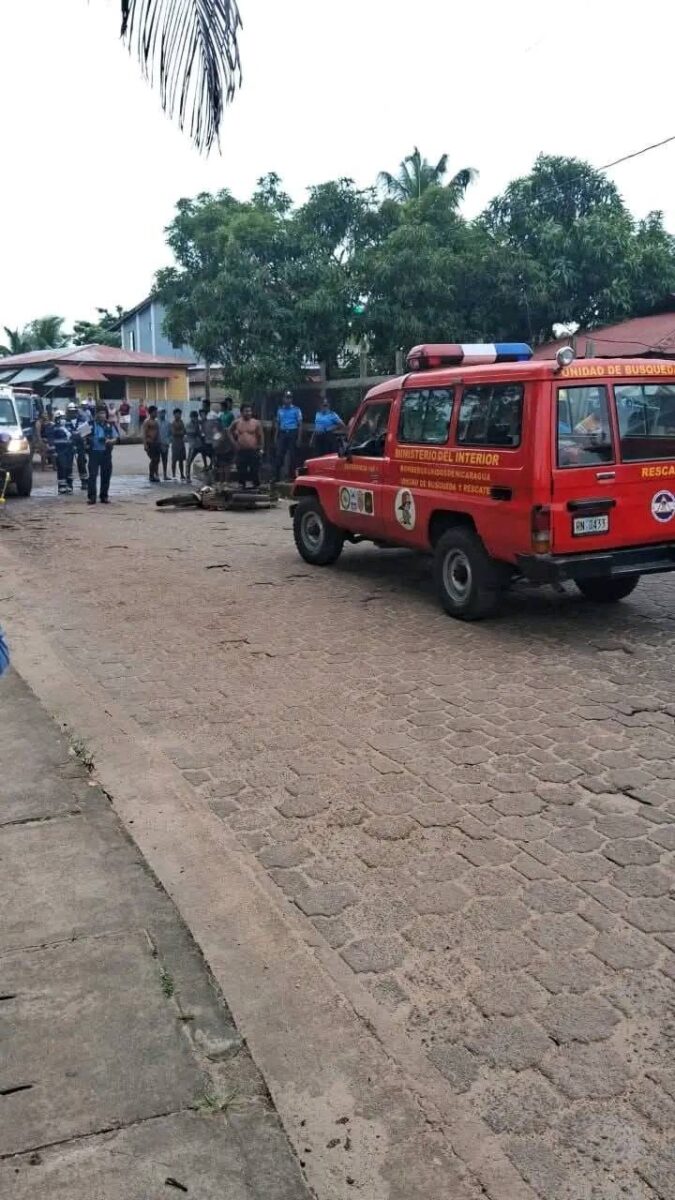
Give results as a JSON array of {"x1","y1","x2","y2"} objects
[{"x1": 37, "y1": 401, "x2": 120, "y2": 504}]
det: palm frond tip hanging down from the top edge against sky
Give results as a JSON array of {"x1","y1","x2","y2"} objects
[{"x1": 121, "y1": 0, "x2": 241, "y2": 152}]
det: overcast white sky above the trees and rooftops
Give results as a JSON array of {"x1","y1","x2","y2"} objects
[{"x1": 0, "y1": 0, "x2": 675, "y2": 326}]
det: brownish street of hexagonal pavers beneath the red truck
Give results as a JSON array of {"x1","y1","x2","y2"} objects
[{"x1": 0, "y1": 449, "x2": 675, "y2": 1200}]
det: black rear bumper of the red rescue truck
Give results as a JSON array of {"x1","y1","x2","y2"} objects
[{"x1": 516, "y1": 541, "x2": 675, "y2": 583}]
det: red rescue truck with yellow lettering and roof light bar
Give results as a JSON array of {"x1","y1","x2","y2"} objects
[{"x1": 293, "y1": 342, "x2": 675, "y2": 620}]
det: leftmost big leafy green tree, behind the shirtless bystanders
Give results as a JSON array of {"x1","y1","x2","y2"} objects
[{"x1": 156, "y1": 175, "x2": 376, "y2": 395}]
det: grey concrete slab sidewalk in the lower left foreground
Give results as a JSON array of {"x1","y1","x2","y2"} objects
[{"x1": 0, "y1": 673, "x2": 310, "y2": 1200}]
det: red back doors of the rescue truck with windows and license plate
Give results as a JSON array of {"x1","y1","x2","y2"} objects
[{"x1": 551, "y1": 380, "x2": 675, "y2": 554}]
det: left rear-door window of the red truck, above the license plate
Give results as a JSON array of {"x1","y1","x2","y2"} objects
[{"x1": 555, "y1": 384, "x2": 614, "y2": 467}]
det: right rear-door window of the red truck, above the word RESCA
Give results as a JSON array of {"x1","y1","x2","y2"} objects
[{"x1": 614, "y1": 383, "x2": 675, "y2": 462}]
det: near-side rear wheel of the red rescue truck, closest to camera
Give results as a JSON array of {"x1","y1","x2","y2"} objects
[{"x1": 434, "y1": 526, "x2": 503, "y2": 620}]
